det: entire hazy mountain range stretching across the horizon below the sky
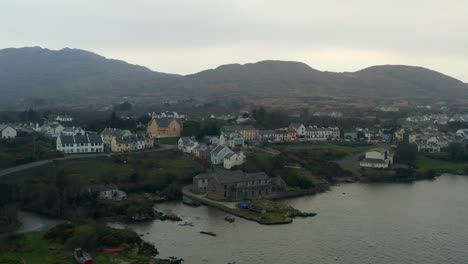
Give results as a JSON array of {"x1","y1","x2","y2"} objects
[{"x1": 0, "y1": 47, "x2": 468, "y2": 107}]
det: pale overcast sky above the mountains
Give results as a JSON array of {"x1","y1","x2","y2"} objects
[{"x1": 0, "y1": 0, "x2": 468, "y2": 81}]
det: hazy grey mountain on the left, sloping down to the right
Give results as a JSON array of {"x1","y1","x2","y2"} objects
[{"x1": 0, "y1": 47, "x2": 174, "y2": 106}]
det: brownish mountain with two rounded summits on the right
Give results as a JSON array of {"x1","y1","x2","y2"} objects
[{"x1": 175, "y1": 61, "x2": 468, "y2": 100}]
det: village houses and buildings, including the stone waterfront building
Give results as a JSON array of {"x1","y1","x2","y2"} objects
[{"x1": 0, "y1": 108, "x2": 468, "y2": 205}]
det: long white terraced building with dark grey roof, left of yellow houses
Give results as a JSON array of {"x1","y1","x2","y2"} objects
[{"x1": 56, "y1": 135, "x2": 104, "y2": 154}]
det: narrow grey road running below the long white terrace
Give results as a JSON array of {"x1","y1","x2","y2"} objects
[{"x1": 0, "y1": 145, "x2": 177, "y2": 177}]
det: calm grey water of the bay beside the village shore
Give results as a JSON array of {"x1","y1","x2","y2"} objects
[{"x1": 112, "y1": 175, "x2": 468, "y2": 264}]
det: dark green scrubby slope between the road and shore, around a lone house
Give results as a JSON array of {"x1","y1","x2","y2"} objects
[{"x1": 2, "y1": 151, "x2": 205, "y2": 219}]
